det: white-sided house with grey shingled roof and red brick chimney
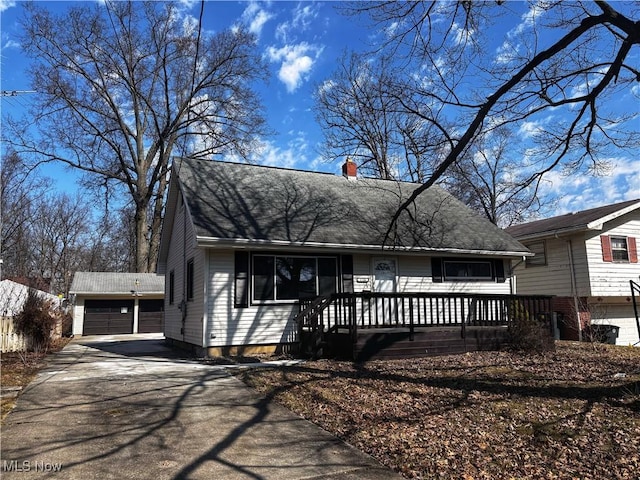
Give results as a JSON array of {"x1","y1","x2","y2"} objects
[{"x1": 158, "y1": 159, "x2": 530, "y2": 356}]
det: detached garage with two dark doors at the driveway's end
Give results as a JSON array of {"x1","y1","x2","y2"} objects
[{"x1": 69, "y1": 272, "x2": 164, "y2": 335}]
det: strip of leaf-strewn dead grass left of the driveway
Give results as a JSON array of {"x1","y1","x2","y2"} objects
[{"x1": 0, "y1": 338, "x2": 70, "y2": 420}]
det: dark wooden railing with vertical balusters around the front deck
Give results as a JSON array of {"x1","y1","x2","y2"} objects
[{"x1": 296, "y1": 292, "x2": 552, "y2": 352}]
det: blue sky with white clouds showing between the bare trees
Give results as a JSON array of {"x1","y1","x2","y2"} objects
[{"x1": 0, "y1": 0, "x2": 640, "y2": 218}]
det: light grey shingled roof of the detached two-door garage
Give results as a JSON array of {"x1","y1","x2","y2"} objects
[{"x1": 69, "y1": 272, "x2": 164, "y2": 295}]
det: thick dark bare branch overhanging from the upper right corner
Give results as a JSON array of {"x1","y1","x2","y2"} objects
[{"x1": 336, "y1": 1, "x2": 640, "y2": 235}]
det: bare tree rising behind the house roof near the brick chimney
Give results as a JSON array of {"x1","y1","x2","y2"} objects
[{"x1": 315, "y1": 54, "x2": 436, "y2": 181}]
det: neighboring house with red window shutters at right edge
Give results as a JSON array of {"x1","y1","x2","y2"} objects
[{"x1": 507, "y1": 200, "x2": 640, "y2": 345}]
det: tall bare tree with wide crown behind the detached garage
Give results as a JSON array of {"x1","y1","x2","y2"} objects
[{"x1": 6, "y1": 0, "x2": 267, "y2": 272}]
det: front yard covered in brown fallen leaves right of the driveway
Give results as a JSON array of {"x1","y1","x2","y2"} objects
[{"x1": 240, "y1": 342, "x2": 640, "y2": 480}]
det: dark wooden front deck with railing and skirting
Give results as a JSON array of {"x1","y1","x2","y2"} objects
[{"x1": 296, "y1": 293, "x2": 553, "y2": 362}]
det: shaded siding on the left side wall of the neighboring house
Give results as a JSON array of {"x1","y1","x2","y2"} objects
[{"x1": 515, "y1": 234, "x2": 590, "y2": 297}]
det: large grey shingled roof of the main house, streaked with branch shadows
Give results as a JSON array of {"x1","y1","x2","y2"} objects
[{"x1": 165, "y1": 159, "x2": 528, "y2": 256}]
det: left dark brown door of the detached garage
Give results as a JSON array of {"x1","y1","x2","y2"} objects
[{"x1": 82, "y1": 300, "x2": 134, "y2": 335}]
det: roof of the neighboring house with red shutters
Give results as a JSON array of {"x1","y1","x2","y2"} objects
[{"x1": 506, "y1": 199, "x2": 640, "y2": 239}]
